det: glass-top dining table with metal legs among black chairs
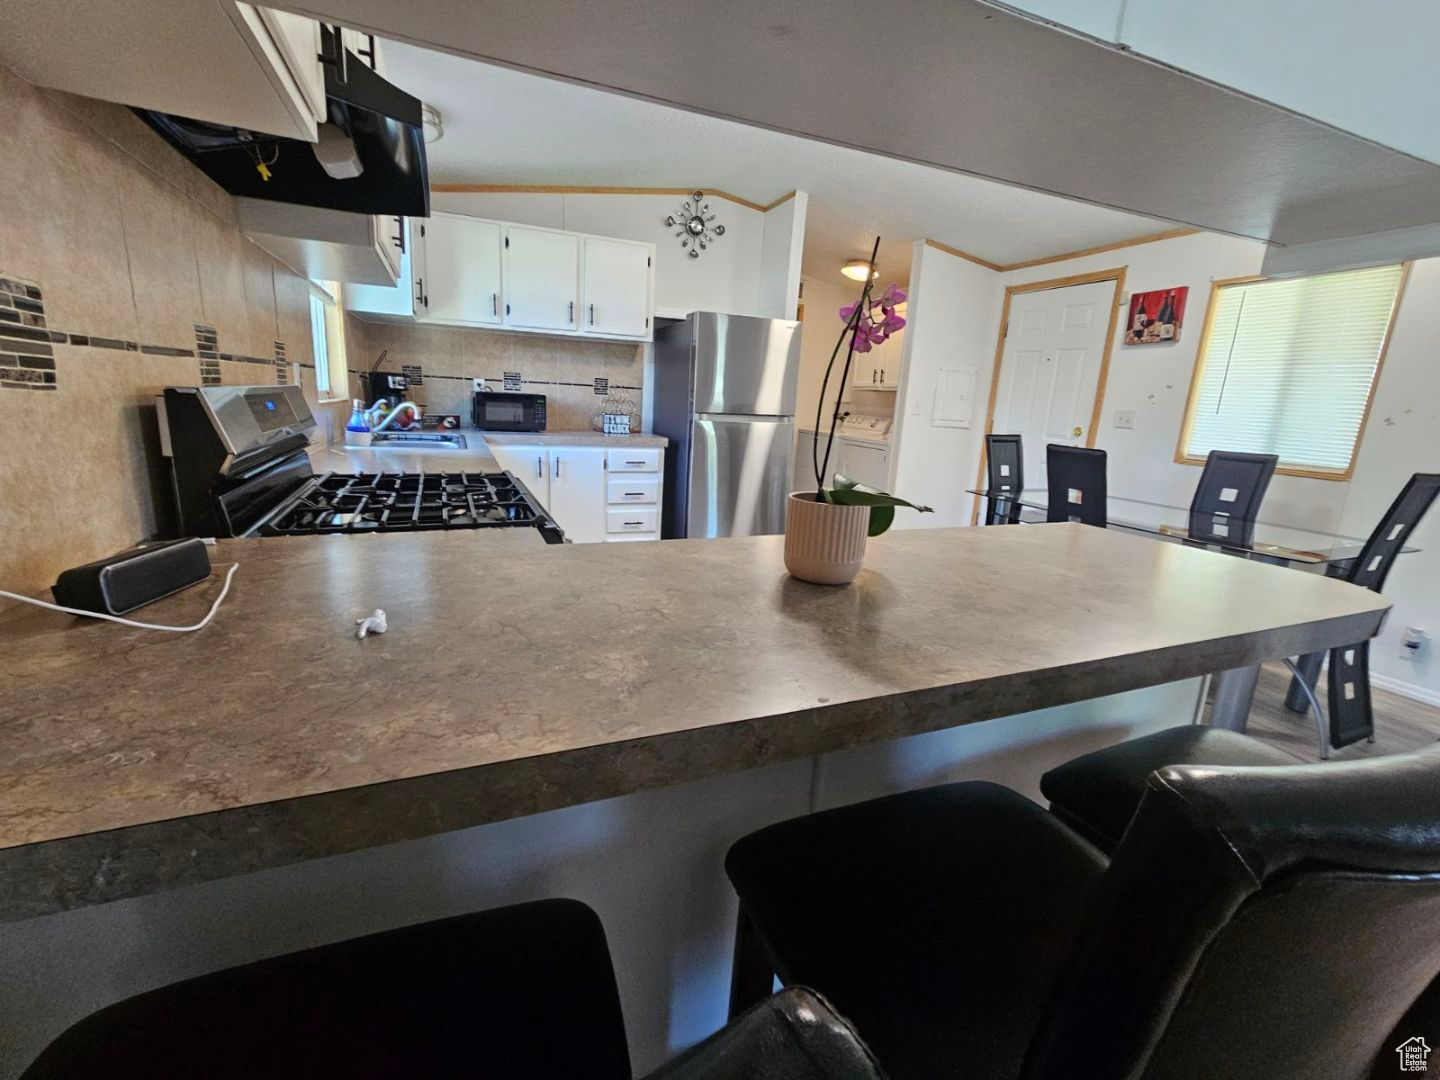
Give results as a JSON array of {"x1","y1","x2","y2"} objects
[{"x1": 968, "y1": 488, "x2": 1420, "y2": 732}]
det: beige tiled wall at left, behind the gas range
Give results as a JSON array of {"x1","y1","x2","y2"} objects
[{"x1": 0, "y1": 68, "x2": 324, "y2": 592}]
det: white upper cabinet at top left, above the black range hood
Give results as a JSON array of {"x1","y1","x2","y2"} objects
[{"x1": 0, "y1": 0, "x2": 325, "y2": 143}]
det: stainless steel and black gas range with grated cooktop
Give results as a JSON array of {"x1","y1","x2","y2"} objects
[{"x1": 158, "y1": 386, "x2": 564, "y2": 543}]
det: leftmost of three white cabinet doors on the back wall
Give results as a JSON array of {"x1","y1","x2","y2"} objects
[{"x1": 416, "y1": 213, "x2": 500, "y2": 325}]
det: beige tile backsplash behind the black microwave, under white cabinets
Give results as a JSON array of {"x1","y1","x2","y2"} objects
[{"x1": 346, "y1": 315, "x2": 645, "y2": 431}]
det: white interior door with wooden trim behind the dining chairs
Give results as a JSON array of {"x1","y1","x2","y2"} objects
[{"x1": 991, "y1": 281, "x2": 1115, "y2": 488}]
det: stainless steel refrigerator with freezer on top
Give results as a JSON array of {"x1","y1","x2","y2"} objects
[{"x1": 654, "y1": 311, "x2": 801, "y2": 540}]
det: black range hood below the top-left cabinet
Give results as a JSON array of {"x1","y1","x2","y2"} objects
[{"x1": 135, "y1": 26, "x2": 431, "y2": 217}]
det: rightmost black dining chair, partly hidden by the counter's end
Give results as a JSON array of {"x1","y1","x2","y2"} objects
[{"x1": 1284, "y1": 472, "x2": 1440, "y2": 749}]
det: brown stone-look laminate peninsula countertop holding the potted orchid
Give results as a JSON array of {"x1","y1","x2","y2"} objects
[{"x1": 0, "y1": 524, "x2": 1388, "y2": 920}]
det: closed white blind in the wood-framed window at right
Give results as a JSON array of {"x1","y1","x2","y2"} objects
[{"x1": 1184, "y1": 266, "x2": 1404, "y2": 474}]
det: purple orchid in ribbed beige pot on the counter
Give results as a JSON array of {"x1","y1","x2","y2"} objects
[{"x1": 785, "y1": 238, "x2": 932, "y2": 585}]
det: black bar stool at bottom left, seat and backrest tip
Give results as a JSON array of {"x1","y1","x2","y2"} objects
[{"x1": 22, "y1": 900, "x2": 881, "y2": 1080}]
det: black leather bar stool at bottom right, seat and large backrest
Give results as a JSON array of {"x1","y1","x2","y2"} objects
[{"x1": 726, "y1": 747, "x2": 1440, "y2": 1080}]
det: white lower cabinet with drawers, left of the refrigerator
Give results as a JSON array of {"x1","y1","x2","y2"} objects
[{"x1": 490, "y1": 444, "x2": 664, "y2": 544}]
